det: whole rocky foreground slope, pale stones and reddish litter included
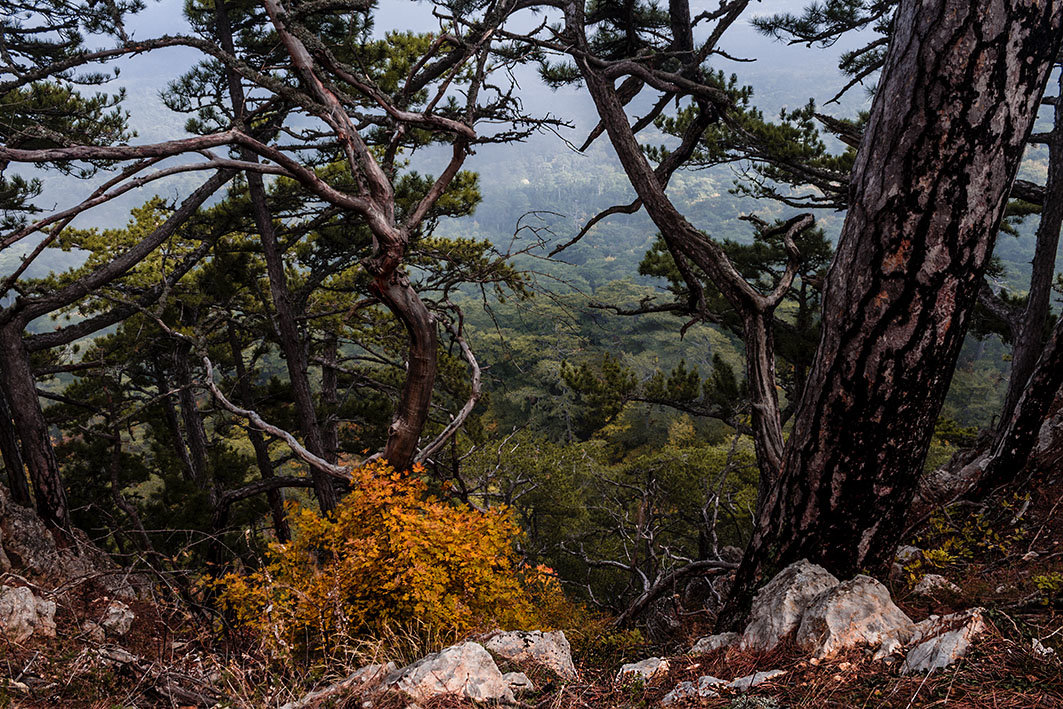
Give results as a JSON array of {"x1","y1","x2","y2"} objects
[{"x1": 0, "y1": 465, "x2": 1063, "y2": 709}]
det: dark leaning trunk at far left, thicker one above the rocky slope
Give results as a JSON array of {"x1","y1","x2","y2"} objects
[{"x1": 0, "y1": 325, "x2": 70, "y2": 529}]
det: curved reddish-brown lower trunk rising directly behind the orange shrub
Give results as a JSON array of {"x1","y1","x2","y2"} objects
[{"x1": 374, "y1": 270, "x2": 437, "y2": 470}]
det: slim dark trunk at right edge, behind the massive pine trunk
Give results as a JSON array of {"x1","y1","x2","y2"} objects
[{"x1": 997, "y1": 72, "x2": 1063, "y2": 427}]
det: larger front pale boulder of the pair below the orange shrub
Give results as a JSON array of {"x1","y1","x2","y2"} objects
[{"x1": 384, "y1": 642, "x2": 516, "y2": 704}]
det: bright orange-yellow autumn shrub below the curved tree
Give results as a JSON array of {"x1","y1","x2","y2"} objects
[{"x1": 217, "y1": 463, "x2": 564, "y2": 649}]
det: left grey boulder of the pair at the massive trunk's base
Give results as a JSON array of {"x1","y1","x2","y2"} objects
[{"x1": 741, "y1": 559, "x2": 839, "y2": 651}]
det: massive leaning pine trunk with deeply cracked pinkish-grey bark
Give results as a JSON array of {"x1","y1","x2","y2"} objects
[{"x1": 721, "y1": 0, "x2": 1063, "y2": 625}]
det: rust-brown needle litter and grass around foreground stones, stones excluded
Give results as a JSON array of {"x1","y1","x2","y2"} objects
[{"x1": 0, "y1": 467, "x2": 1063, "y2": 709}]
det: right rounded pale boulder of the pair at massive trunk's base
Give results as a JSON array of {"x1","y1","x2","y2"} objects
[{"x1": 796, "y1": 575, "x2": 913, "y2": 658}]
